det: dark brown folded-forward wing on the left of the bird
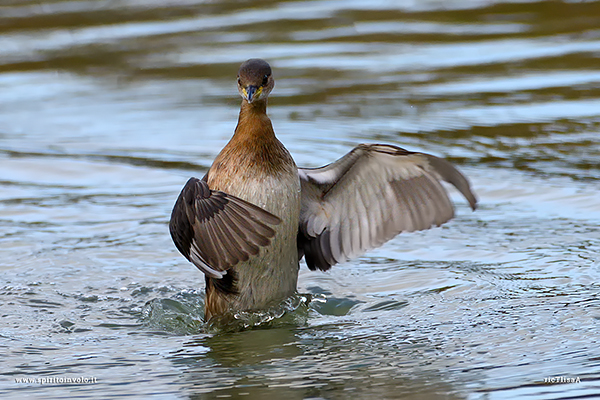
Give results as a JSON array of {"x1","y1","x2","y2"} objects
[{"x1": 169, "y1": 178, "x2": 281, "y2": 278}]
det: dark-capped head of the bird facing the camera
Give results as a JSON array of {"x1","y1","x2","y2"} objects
[{"x1": 238, "y1": 58, "x2": 275, "y2": 103}]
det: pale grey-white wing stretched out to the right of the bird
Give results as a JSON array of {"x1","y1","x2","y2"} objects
[{"x1": 298, "y1": 144, "x2": 477, "y2": 270}]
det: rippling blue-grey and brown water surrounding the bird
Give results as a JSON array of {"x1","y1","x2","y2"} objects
[{"x1": 0, "y1": 0, "x2": 600, "y2": 399}]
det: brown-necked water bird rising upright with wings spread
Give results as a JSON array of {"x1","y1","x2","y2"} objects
[{"x1": 169, "y1": 58, "x2": 477, "y2": 321}]
